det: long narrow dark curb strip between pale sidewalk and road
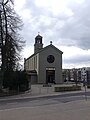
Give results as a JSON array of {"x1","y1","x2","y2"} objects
[{"x1": 0, "y1": 91, "x2": 90, "y2": 104}]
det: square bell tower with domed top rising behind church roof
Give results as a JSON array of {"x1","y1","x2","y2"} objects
[{"x1": 34, "y1": 34, "x2": 43, "y2": 53}]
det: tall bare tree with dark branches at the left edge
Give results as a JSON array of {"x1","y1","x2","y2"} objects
[{"x1": 1, "y1": 0, "x2": 25, "y2": 71}]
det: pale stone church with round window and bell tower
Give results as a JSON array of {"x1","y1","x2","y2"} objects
[{"x1": 24, "y1": 34, "x2": 63, "y2": 84}]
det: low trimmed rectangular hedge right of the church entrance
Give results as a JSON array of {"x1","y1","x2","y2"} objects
[{"x1": 55, "y1": 85, "x2": 81, "y2": 92}]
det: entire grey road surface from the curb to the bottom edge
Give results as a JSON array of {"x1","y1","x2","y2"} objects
[{"x1": 0, "y1": 92, "x2": 90, "y2": 120}]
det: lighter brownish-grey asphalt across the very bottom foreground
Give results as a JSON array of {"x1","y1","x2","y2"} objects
[{"x1": 0, "y1": 96, "x2": 90, "y2": 120}]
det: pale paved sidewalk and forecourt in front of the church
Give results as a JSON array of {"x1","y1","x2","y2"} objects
[{"x1": 0, "y1": 85, "x2": 90, "y2": 101}]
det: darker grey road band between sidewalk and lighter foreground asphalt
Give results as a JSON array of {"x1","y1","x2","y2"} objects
[{"x1": 0, "y1": 92, "x2": 90, "y2": 110}]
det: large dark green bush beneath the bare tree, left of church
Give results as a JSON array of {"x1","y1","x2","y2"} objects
[{"x1": 3, "y1": 71, "x2": 29, "y2": 92}]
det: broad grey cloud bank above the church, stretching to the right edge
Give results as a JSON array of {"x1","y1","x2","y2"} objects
[{"x1": 20, "y1": 0, "x2": 90, "y2": 49}]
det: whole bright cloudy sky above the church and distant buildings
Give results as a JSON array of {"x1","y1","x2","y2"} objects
[{"x1": 15, "y1": 0, "x2": 90, "y2": 68}]
